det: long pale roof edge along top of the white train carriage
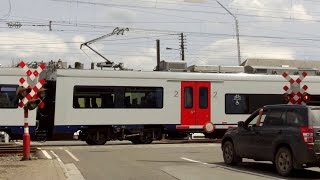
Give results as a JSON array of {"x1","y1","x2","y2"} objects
[{"x1": 56, "y1": 69, "x2": 320, "y2": 82}]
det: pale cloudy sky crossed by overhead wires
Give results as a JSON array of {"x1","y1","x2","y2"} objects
[{"x1": 0, "y1": 0, "x2": 320, "y2": 71}]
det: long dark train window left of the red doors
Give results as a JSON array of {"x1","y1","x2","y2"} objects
[{"x1": 73, "y1": 86, "x2": 163, "y2": 108}]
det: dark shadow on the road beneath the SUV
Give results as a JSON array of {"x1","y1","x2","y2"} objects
[{"x1": 214, "y1": 162, "x2": 320, "y2": 179}]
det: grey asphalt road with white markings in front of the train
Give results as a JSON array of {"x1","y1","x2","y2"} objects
[{"x1": 37, "y1": 141, "x2": 320, "y2": 180}]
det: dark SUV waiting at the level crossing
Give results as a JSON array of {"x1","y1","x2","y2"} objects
[{"x1": 221, "y1": 105, "x2": 320, "y2": 176}]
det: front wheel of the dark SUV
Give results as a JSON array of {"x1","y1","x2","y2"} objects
[{"x1": 222, "y1": 141, "x2": 242, "y2": 165}]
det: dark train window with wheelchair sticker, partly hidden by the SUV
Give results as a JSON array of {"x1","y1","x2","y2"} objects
[{"x1": 225, "y1": 94, "x2": 284, "y2": 114}]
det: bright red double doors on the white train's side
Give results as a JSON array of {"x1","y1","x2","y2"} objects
[{"x1": 181, "y1": 81, "x2": 211, "y2": 126}]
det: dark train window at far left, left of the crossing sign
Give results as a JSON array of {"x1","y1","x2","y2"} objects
[{"x1": 0, "y1": 85, "x2": 18, "y2": 108}]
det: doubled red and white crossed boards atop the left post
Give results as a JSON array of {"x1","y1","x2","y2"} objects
[{"x1": 19, "y1": 61, "x2": 45, "y2": 108}]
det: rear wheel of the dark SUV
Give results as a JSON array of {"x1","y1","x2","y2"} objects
[{"x1": 274, "y1": 147, "x2": 293, "y2": 176}]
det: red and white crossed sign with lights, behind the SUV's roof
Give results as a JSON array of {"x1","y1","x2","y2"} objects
[{"x1": 282, "y1": 72, "x2": 308, "y2": 104}]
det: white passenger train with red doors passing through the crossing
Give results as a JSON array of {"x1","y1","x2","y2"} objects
[{"x1": 0, "y1": 68, "x2": 320, "y2": 145}]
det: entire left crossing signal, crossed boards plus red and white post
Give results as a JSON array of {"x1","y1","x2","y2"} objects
[{"x1": 18, "y1": 61, "x2": 45, "y2": 160}]
